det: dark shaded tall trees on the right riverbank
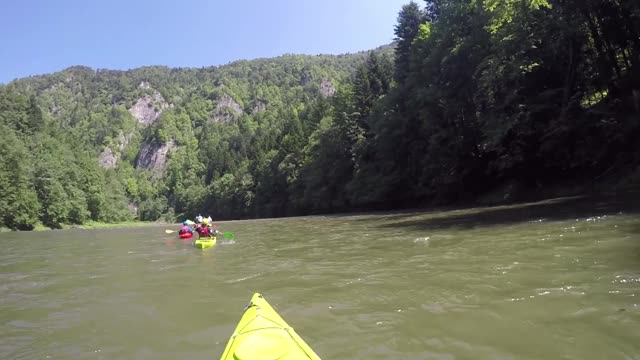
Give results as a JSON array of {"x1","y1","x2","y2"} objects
[{"x1": 330, "y1": 0, "x2": 640, "y2": 205}]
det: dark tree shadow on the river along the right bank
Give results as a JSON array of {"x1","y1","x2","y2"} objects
[{"x1": 373, "y1": 194, "x2": 640, "y2": 233}]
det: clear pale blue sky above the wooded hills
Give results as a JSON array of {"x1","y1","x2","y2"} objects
[{"x1": 0, "y1": 0, "x2": 409, "y2": 83}]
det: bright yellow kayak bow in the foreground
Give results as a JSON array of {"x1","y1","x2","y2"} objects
[{"x1": 220, "y1": 293, "x2": 320, "y2": 360}]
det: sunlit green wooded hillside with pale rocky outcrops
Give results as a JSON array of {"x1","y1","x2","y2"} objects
[{"x1": 0, "y1": 46, "x2": 393, "y2": 229}]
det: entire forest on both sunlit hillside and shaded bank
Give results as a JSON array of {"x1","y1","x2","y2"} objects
[{"x1": 0, "y1": 0, "x2": 640, "y2": 230}]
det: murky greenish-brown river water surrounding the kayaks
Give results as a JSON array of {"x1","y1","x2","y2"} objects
[{"x1": 0, "y1": 198, "x2": 640, "y2": 360}]
